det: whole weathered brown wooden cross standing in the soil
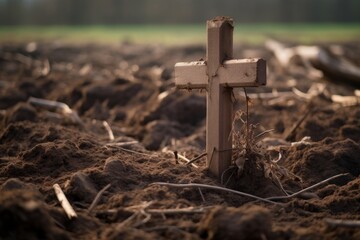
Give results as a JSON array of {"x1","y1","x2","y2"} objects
[{"x1": 175, "y1": 17, "x2": 266, "y2": 177}]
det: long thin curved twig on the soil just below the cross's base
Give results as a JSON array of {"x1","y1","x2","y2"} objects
[{"x1": 150, "y1": 182, "x2": 281, "y2": 205}]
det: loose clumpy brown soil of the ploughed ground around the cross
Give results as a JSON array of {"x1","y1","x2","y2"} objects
[{"x1": 0, "y1": 42, "x2": 360, "y2": 239}]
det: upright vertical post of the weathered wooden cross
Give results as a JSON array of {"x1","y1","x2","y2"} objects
[{"x1": 206, "y1": 17, "x2": 233, "y2": 177}]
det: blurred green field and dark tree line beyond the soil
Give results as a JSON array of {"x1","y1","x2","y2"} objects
[{"x1": 0, "y1": 0, "x2": 360, "y2": 43}]
